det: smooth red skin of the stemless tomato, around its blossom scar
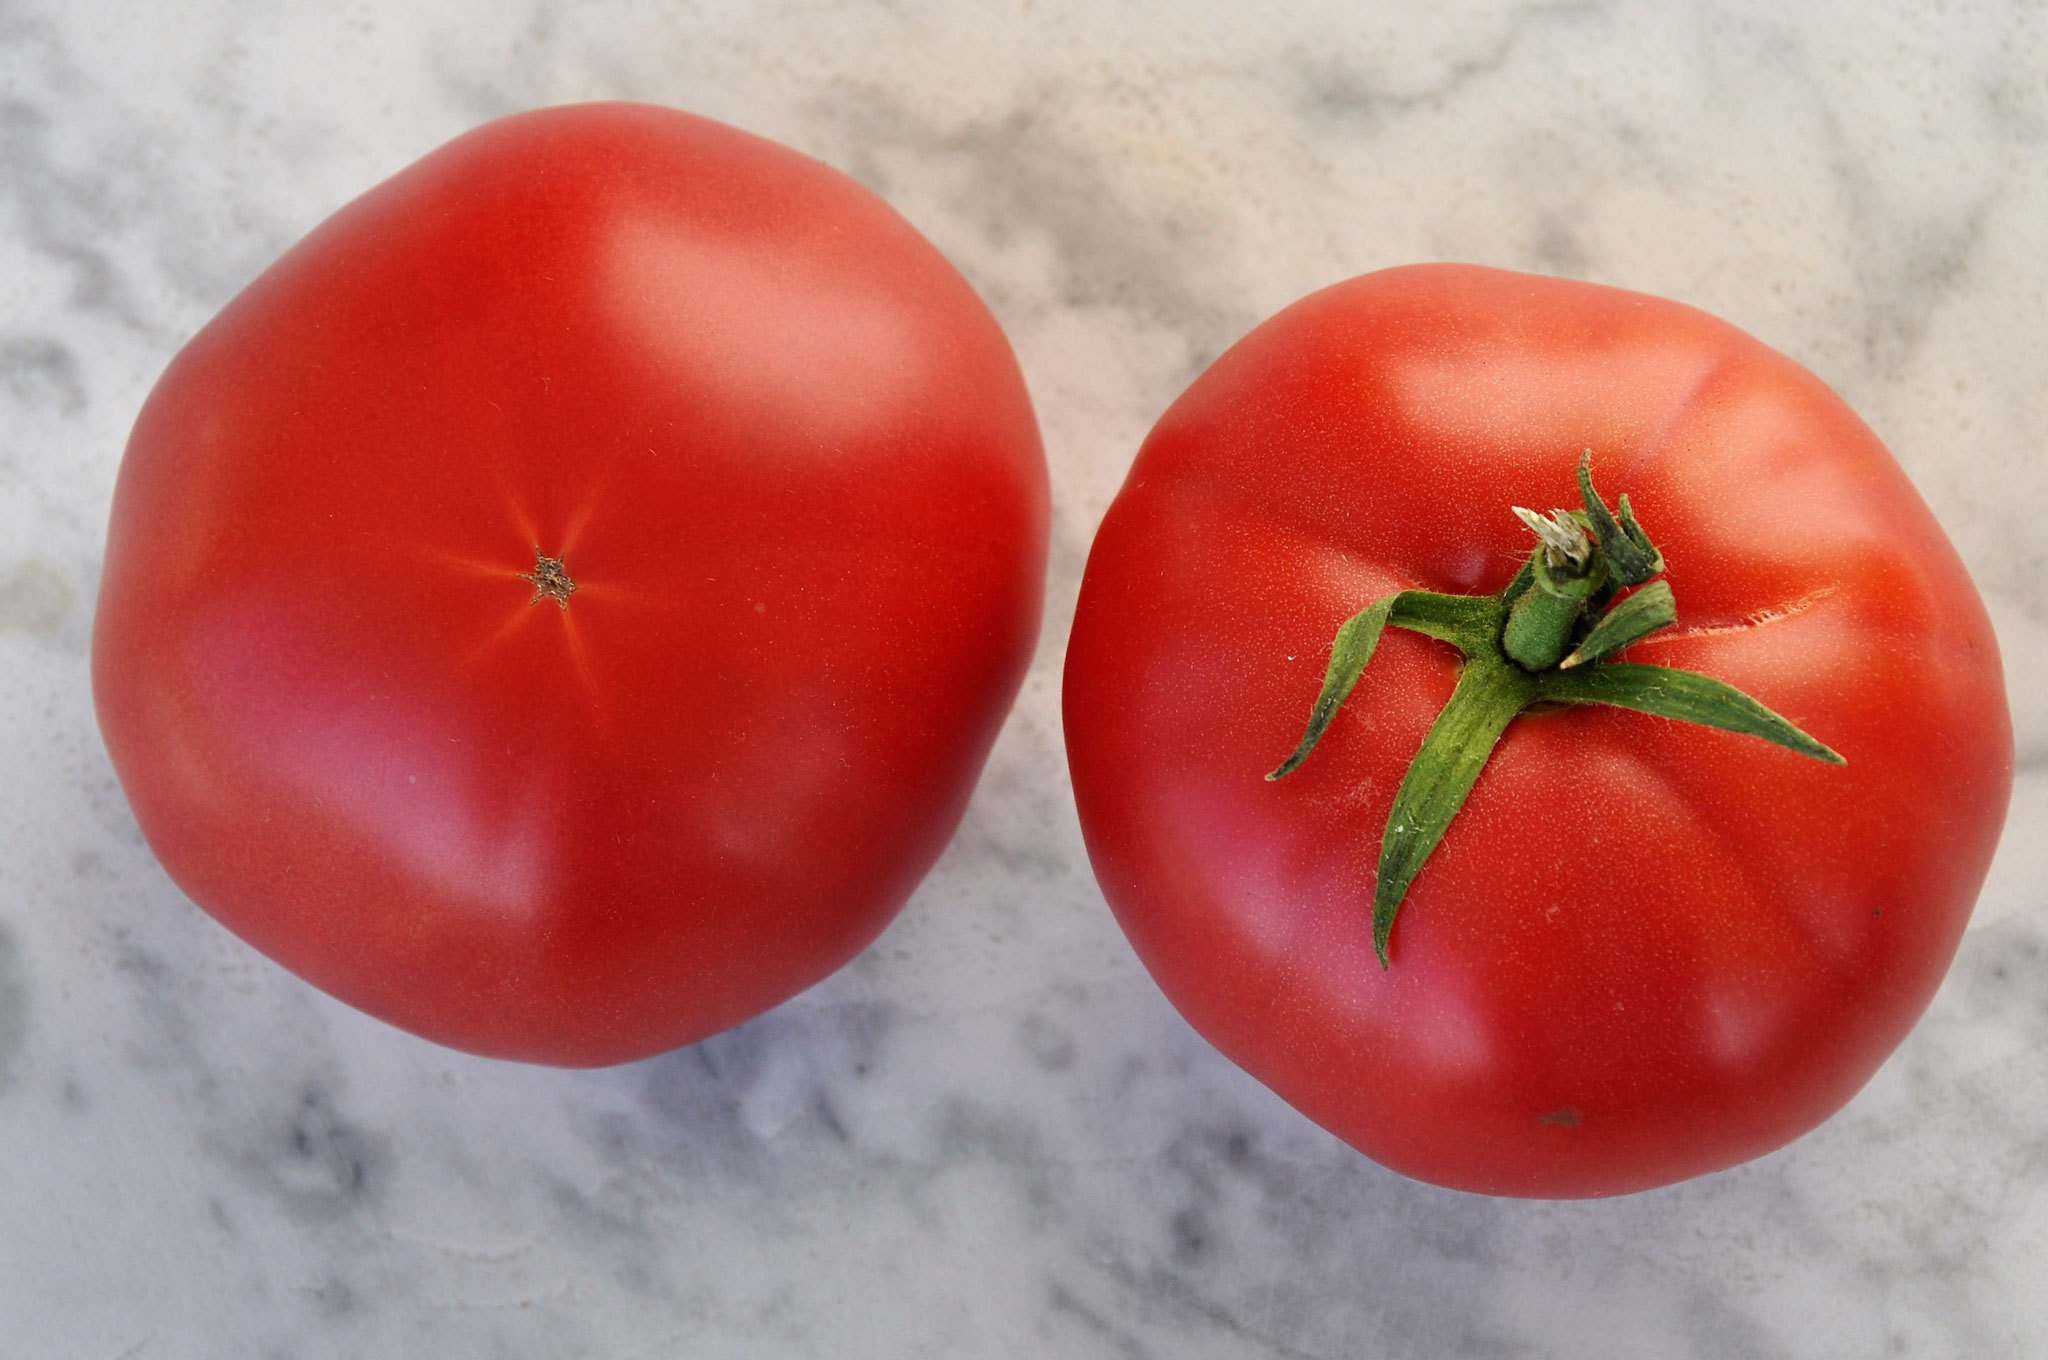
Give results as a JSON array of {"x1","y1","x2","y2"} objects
[{"x1": 92, "y1": 104, "x2": 1049, "y2": 1065}]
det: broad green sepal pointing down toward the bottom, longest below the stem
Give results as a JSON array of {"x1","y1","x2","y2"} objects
[{"x1": 1372, "y1": 651, "x2": 1536, "y2": 969}]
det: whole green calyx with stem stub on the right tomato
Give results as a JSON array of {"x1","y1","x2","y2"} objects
[{"x1": 1266, "y1": 449, "x2": 1845, "y2": 969}]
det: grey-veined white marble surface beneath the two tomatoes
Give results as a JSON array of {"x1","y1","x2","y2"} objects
[{"x1": 0, "y1": 0, "x2": 2048, "y2": 1360}]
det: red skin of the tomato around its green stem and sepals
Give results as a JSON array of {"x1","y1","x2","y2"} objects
[{"x1": 1065, "y1": 266, "x2": 2013, "y2": 1198}]
